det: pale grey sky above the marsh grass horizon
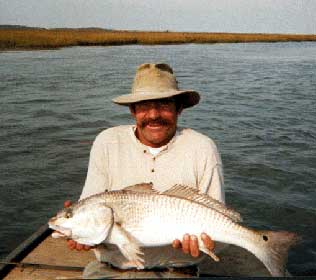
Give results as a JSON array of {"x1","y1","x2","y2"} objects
[{"x1": 0, "y1": 0, "x2": 316, "y2": 34}]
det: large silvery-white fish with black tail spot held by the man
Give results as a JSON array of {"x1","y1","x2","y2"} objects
[{"x1": 49, "y1": 184, "x2": 297, "y2": 276}]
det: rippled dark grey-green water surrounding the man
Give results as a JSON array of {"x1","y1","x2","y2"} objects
[{"x1": 0, "y1": 43, "x2": 316, "y2": 275}]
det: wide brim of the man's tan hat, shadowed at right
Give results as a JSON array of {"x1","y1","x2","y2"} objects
[{"x1": 112, "y1": 90, "x2": 200, "y2": 108}]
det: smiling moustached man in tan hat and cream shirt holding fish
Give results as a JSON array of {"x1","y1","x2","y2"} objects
[{"x1": 68, "y1": 63, "x2": 225, "y2": 278}]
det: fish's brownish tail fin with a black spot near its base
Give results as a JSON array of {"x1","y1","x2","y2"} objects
[{"x1": 255, "y1": 231, "x2": 299, "y2": 277}]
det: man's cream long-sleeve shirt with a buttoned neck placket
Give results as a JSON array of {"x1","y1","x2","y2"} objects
[{"x1": 80, "y1": 125, "x2": 225, "y2": 268}]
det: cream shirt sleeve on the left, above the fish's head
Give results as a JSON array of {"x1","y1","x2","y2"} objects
[{"x1": 80, "y1": 137, "x2": 109, "y2": 199}]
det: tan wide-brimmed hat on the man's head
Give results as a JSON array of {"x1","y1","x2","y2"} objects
[{"x1": 112, "y1": 63, "x2": 200, "y2": 108}]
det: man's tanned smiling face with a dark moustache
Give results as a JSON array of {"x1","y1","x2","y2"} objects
[{"x1": 130, "y1": 98, "x2": 181, "y2": 148}]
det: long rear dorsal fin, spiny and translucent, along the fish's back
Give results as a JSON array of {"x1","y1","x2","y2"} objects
[{"x1": 162, "y1": 185, "x2": 242, "y2": 222}]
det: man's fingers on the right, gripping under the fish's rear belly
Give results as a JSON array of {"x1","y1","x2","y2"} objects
[{"x1": 172, "y1": 232, "x2": 215, "y2": 258}]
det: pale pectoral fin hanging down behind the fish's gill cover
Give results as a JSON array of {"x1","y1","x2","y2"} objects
[{"x1": 111, "y1": 223, "x2": 144, "y2": 269}]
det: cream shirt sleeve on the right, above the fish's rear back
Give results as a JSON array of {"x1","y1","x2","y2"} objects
[{"x1": 199, "y1": 143, "x2": 225, "y2": 203}]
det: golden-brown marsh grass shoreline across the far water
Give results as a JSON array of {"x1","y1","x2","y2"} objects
[{"x1": 0, "y1": 29, "x2": 316, "y2": 51}]
